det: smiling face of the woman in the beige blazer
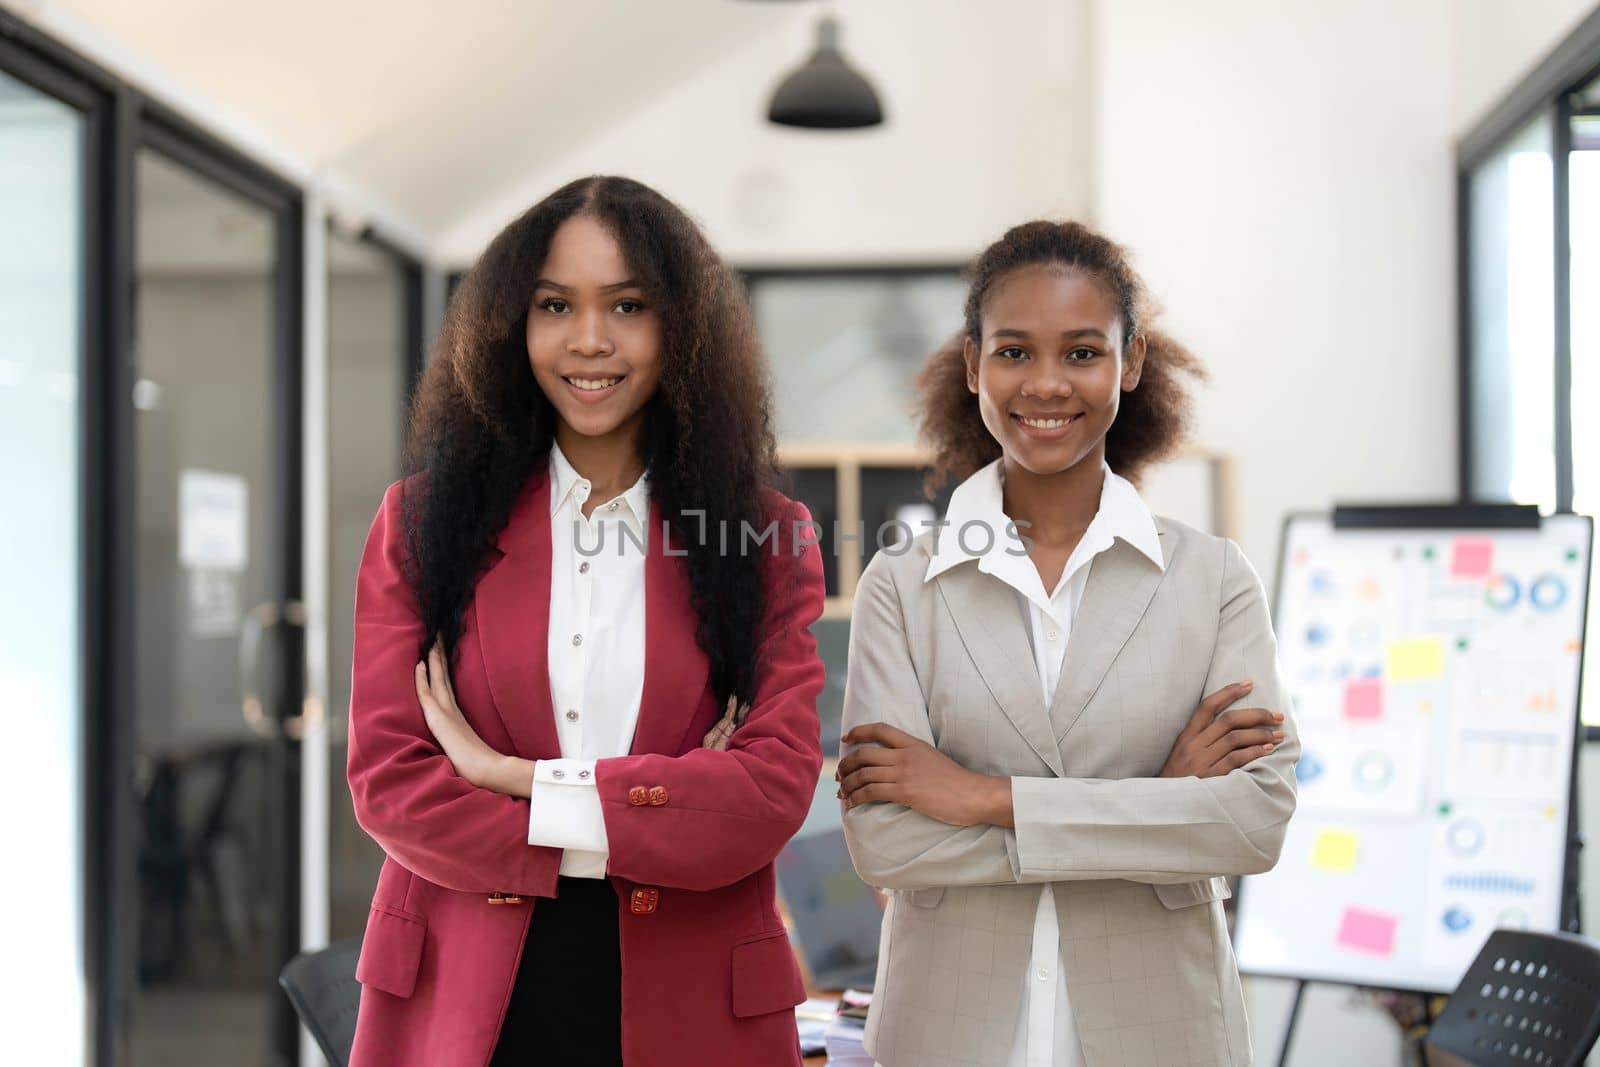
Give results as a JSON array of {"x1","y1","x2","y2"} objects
[{"x1": 965, "y1": 264, "x2": 1144, "y2": 475}]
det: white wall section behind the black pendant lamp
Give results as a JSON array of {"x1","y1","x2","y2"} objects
[{"x1": 438, "y1": 0, "x2": 1091, "y2": 271}]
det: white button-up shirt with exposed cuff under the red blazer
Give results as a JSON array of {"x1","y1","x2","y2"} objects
[{"x1": 528, "y1": 443, "x2": 650, "y2": 878}]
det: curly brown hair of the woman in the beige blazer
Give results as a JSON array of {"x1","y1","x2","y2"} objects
[{"x1": 917, "y1": 221, "x2": 1206, "y2": 493}]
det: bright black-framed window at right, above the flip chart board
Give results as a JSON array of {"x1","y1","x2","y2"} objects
[{"x1": 1458, "y1": 11, "x2": 1600, "y2": 739}]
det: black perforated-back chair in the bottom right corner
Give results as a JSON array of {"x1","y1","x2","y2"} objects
[{"x1": 1426, "y1": 929, "x2": 1600, "y2": 1067}]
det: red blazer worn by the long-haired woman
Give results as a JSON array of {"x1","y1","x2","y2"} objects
[{"x1": 349, "y1": 472, "x2": 822, "y2": 1067}]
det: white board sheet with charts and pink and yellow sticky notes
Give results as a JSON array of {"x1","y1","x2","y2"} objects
[{"x1": 1235, "y1": 515, "x2": 1600, "y2": 992}]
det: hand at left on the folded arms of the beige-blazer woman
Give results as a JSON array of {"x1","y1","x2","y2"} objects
[{"x1": 834, "y1": 723, "x2": 1013, "y2": 825}]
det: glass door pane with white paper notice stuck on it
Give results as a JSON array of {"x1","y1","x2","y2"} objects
[{"x1": 123, "y1": 141, "x2": 304, "y2": 1067}]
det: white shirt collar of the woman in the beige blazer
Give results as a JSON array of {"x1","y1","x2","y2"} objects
[{"x1": 923, "y1": 459, "x2": 1166, "y2": 587}]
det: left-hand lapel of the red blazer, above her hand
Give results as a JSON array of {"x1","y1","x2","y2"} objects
[{"x1": 472, "y1": 470, "x2": 562, "y2": 760}]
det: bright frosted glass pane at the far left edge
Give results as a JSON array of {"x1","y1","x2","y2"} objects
[{"x1": 0, "y1": 64, "x2": 88, "y2": 1064}]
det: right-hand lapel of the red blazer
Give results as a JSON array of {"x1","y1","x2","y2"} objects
[{"x1": 632, "y1": 501, "x2": 710, "y2": 755}]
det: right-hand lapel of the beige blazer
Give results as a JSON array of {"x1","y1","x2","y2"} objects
[{"x1": 1050, "y1": 537, "x2": 1174, "y2": 744}]
